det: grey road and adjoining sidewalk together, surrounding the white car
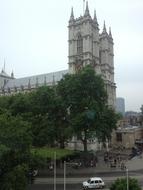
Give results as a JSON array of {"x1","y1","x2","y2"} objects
[{"x1": 31, "y1": 153, "x2": 143, "y2": 190}]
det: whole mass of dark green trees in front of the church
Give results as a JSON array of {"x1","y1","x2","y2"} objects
[{"x1": 0, "y1": 66, "x2": 118, "y2": 190}]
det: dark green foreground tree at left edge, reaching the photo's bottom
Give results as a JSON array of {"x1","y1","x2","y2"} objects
[{"x1": 0, "y1": 112, "x2": 32, "y2": 190}]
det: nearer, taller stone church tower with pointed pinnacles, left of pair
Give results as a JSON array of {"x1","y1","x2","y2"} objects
[{"x1": 68, "y1": 2, "x2": 100, "y2": 73}]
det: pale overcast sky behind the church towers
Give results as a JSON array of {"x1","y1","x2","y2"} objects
[{"x1": 0, "y1": 0, "x2": 143, "y2": 111}]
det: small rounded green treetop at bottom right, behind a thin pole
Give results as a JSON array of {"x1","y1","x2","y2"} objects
[{"x1": 110, "y1": 178, "x2": 141, "y2": 190}]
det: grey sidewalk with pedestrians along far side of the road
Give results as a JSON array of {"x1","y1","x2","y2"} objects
[{"x1": 38, "y1": 154, "x2": 143, "y2": 177}]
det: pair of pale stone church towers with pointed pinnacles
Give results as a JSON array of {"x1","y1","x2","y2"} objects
[{"x1": 68, "y1": 2, "x2": 116, "y2": 107}]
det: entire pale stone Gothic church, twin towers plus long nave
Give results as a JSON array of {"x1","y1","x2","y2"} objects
[{"x1": 0, "y1": 2, "x2": 116, "y2": 107}]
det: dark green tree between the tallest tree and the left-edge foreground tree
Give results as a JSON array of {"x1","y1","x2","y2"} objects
[{"x1": 0, "y1": 86, "x2": 71, "y2": 148}]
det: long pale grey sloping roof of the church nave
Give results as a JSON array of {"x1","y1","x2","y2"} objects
[{"x1": 5, "y1": 70, "x2": 68, "y2": 89}]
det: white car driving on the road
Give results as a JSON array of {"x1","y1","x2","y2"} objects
[{"x1": 82, "y1": 177, "x2": 105, "y2": 189}]
